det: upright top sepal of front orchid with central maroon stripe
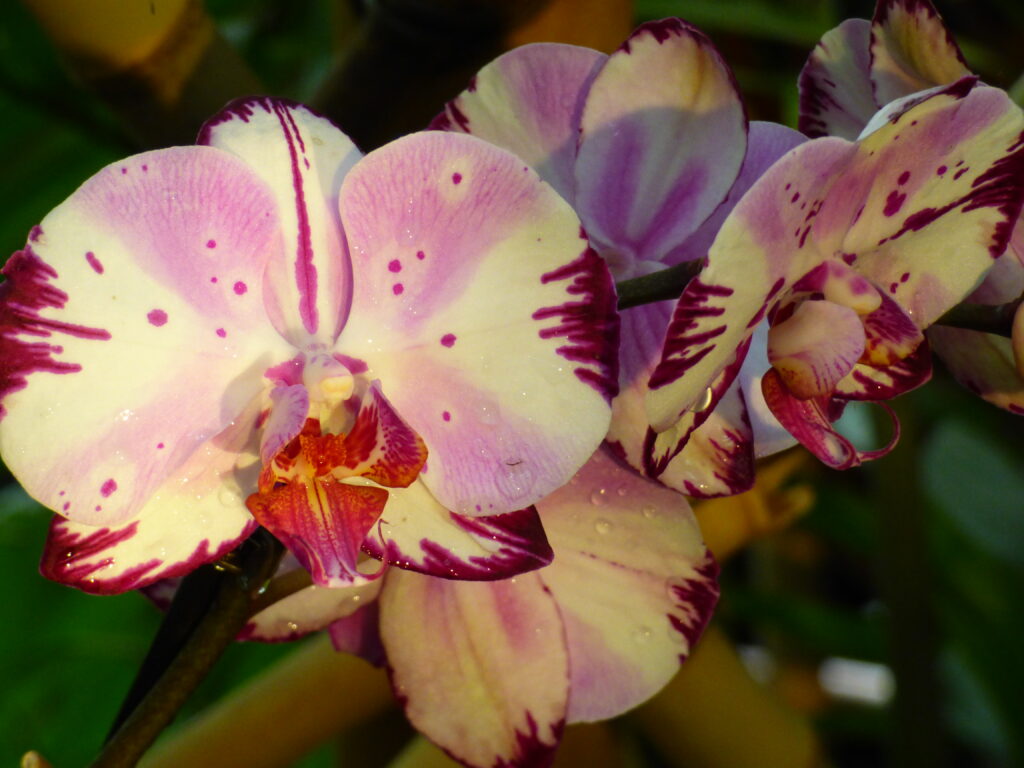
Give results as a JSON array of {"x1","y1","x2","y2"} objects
[{"x1": 199, "y1": 96, "x2": 360, "y2": 347}]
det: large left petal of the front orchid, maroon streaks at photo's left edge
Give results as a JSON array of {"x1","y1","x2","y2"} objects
[{"x1": 0, "y1": 146, "x2": 290, "y2": 526}]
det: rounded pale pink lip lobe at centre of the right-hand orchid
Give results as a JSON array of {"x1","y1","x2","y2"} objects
[{"x1": 768, "y1": 301, "x2": 864, "y2": 399}]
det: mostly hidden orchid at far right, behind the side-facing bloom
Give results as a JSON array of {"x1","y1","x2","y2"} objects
[{"x1": 800, "y1": 0, "x2": 1024, "y2": 414}]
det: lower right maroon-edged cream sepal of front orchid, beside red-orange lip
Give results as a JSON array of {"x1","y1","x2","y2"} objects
[{"x1": 362, "y1": 482, "x2": 551, "y2": 581}]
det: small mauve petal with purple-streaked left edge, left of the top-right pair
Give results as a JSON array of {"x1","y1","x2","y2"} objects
[{"x1": 798, "y1": 18, "x2": 879, "y2": 141}]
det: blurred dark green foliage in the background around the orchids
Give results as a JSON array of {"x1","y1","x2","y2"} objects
[{"x1": 0, "y1": 0, "x2": 1024, "y2": 768}]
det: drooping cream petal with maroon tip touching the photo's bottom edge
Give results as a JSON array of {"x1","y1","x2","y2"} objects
[{"x1": 380, "y1": 568, "x2": 569, "y2": 768}]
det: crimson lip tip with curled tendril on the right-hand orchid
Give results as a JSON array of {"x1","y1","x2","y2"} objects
[{"x1": 761, "y1": 369, "x2": 899, "y2": 469}]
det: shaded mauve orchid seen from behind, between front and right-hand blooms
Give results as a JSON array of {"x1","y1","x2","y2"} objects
[{"x1": 433, "y1": 18, "x2": 804, "y2": 497}]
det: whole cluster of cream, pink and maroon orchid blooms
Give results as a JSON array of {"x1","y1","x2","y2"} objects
[{"x1": 0, "y1": 0, "x2": 1024, "y2": 766}]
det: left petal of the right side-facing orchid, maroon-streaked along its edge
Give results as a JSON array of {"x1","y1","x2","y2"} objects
[{"x1": 646, "y1": 138, "x2": 856, "y2": 431}]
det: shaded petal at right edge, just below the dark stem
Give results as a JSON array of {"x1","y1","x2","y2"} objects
[{"x1": 928, "y1": 325, "x2": 1024, "y2": 415}]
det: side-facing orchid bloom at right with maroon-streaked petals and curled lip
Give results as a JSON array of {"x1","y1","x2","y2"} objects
[{"x1": 647, "y1": 77, "x2": 1024, "y2": 468}]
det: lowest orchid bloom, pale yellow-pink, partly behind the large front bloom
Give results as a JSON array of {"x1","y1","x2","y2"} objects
[{"x1": 233, "y1": 445, "x2": 718, "y2": 768}]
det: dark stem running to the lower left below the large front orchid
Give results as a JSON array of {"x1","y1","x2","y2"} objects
[{"x1": 92, "y1": 528, "x2": 284, "y2": 768}]
